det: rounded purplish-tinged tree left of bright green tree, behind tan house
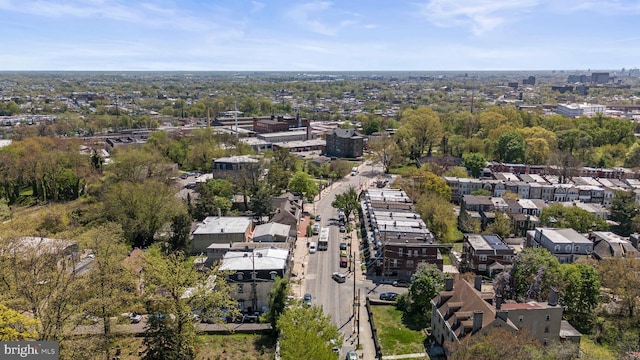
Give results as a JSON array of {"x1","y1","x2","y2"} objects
[{"x1": 511, "y1": 248, "x2": 561, "y2": 301}]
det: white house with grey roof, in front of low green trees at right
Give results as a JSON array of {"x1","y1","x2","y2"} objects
[{"x1": 526, "y1": 228, "x2": 593, "y2": 264}]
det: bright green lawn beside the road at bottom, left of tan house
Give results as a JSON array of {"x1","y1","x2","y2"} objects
[{"x1": 371, "y1": 305, "x2": 427, "y2": 355}]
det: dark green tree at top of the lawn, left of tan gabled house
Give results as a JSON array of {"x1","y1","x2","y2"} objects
[{"x1": 408, "y1": 263, "x2": 444, "y2": 326}]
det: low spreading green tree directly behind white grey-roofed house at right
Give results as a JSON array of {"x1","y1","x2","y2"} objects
[{"x1": 540, "y1": 204, "x2": 609, "y2": 233}]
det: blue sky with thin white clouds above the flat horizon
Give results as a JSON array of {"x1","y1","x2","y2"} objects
[{"x1": 0, "y1": 0, "x2": 640, "y2": 71}]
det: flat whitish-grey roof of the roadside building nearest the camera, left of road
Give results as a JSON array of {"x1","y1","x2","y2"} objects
[{"x1": 220, "y1": 248, "x2": 289, "y2": 271}]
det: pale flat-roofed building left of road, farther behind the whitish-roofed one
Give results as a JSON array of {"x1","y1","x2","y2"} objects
[{"x1": 191, "y1": 216, "x2": 253, "y2": 254}]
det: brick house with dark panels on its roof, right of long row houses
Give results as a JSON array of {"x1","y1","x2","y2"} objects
[{"x1": 462, "y1": 234, "x2": 515, "y2": 277}]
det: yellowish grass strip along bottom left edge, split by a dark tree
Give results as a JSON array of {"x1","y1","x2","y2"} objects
[{"x1": 105, "y1": 334, "x2": 275, "y2": 360}]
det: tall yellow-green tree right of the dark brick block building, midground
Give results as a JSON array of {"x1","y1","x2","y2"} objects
[{"x1": 396, "y1": 106, "x2": 443, "y2": 160}]
